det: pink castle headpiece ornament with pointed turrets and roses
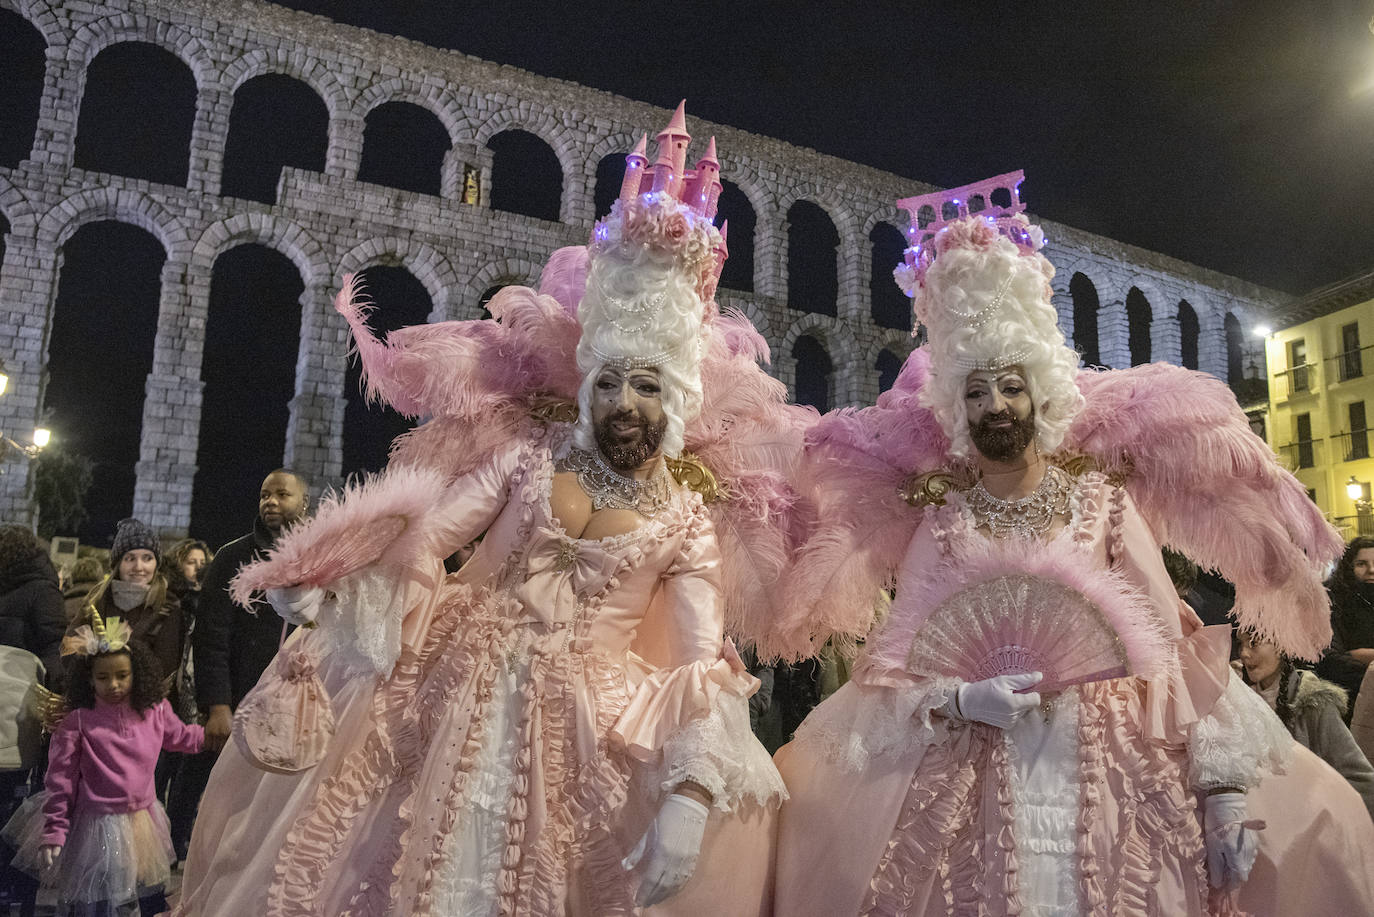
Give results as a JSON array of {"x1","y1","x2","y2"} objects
[{"x1": 588, "y1": 100, "x2": 730, "y2": 302}]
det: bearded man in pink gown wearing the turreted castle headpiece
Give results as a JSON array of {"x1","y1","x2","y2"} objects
[{"x1": 177, "y1": 110, "x2": 804, "y2": 917}]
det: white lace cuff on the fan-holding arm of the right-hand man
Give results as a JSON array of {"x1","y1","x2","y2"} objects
[{"x1": 796, "y1": 678, "x2": 959, "y2": 774}]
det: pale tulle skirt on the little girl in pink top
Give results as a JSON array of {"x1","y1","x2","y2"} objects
[{"x1": 0, "y1": 792, "x2": 176, "y2": 907}]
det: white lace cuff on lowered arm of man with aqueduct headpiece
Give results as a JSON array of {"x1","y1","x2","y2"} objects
[{"x1": 1189, "y1": 672, "x2": 1293, "y2": 791}]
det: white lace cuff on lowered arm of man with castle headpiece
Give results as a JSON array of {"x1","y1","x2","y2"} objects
[{"x1": 650, "y1": 692, "x2": 787, "y2": 811}]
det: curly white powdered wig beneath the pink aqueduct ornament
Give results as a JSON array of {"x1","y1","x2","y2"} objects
[{"x1": 914, "y1": 216, "x2": 1083, "y2": 456}]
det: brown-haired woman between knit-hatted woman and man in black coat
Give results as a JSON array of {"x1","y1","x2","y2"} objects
[{"x1": 158, "y1": 538, "x2": 216, "y2": 859}]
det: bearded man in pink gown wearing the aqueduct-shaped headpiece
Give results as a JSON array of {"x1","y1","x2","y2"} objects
[{"x1": 775, "y1": 173, "x2": 1374, "y2": 917}]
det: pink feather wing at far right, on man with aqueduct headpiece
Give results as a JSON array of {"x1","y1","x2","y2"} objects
[{"x1": 1066, "y1": 363, "x2": 1344, "y2": 660}]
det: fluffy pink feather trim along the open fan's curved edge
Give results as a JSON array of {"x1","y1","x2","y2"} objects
[{"x1": 863, "y1": 538, "x2": 1176, "y2": 692}]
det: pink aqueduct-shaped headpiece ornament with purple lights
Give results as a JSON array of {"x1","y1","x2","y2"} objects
[{"x1": 893, "y1": 169, "x2": 1044, "y2": 297}]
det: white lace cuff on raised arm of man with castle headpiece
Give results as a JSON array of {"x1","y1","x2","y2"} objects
[{"x1": 319, "y1": 566, "x2": 405, "y2": 678}]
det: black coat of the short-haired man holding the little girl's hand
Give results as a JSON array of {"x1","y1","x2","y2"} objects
[{"x1": 191, "y1": 520, "x2": 291, "y2": 714}]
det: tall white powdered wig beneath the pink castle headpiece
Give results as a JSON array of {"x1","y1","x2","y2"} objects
[{"x1": 573, "y1": 230, "x2": 705, "y2": 458}]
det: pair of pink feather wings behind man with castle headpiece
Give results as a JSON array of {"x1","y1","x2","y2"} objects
[{"x1": 322, "y1": 246, "x2": 818, "y2": 653}]
